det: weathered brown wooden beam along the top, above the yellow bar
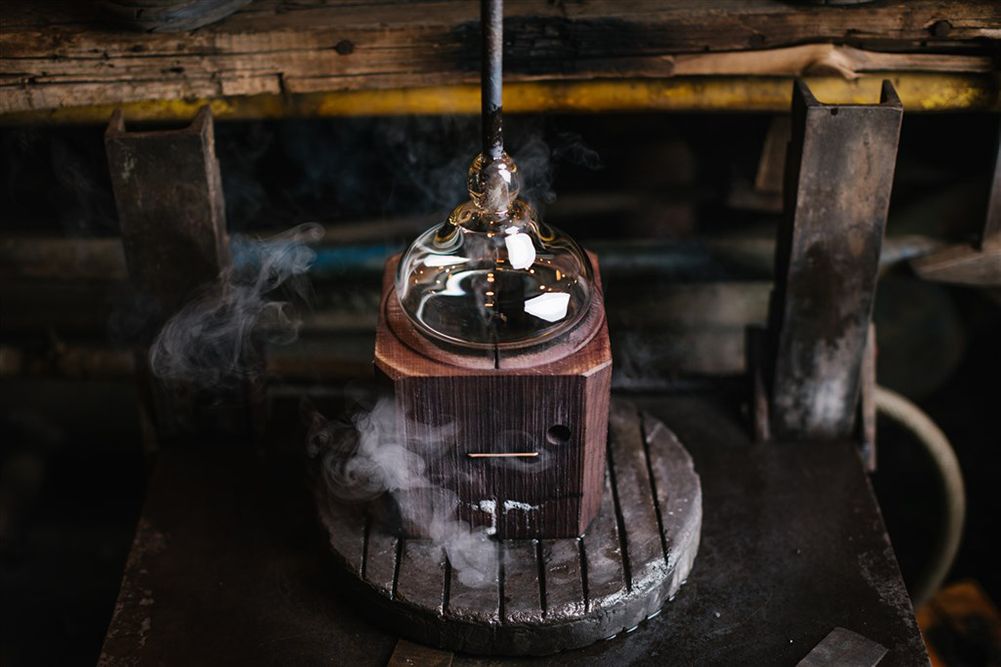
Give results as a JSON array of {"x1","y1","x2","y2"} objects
[{"x1": 0, "y1": 0, "x2": 1001, "y2": 113}]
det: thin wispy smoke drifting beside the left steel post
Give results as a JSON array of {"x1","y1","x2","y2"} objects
[{"x1": 149, "y1": 223, "x2": 323, "y2": 387}]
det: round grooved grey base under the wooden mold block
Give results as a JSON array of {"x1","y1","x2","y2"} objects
[{"x1": 320, "y1": 402, "x2": 702, "y2": 655}]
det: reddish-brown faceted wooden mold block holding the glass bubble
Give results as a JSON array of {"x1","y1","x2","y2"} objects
[{"x1": 375, "y1": 252, "x2": 612, "y2": 539}]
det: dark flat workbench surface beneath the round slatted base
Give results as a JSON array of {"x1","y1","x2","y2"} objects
[{"x1": 101, "y1": 397, "x2": 927, "y2": 667}]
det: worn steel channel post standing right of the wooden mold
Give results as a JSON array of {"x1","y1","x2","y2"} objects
[{"x1": 770, "y1": 81, "x2": 903, "y2": 440}]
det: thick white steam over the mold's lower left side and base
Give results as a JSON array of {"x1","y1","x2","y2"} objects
[{"x1": 306, "y1": 398, "x2": 497, "y2": 587}]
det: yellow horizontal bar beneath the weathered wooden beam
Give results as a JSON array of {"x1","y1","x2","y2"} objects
[{"x1": 0, "y1": 73, "x2": 1001, "y2": 124}]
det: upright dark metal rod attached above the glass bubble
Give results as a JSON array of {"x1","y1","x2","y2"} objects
[{"x1": 479, "y1": 0, "x2": 504, "y2": 161}]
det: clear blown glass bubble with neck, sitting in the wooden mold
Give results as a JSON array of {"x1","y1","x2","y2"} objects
[{"x1": 396, "y1": 150, "x2": 592, "y2": 348}]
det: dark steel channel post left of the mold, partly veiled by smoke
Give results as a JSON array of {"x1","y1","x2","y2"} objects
[{"x1": 104, "y1": 106, "x2": 257, "y2": 444}]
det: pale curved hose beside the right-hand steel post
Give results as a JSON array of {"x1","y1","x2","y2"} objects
[{"x1": 876, "y1": 387, "x2": 966, "y2": 607}]
